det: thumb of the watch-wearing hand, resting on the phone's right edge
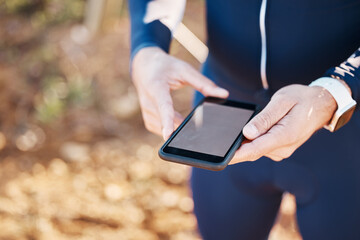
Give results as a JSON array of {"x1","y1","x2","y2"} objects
[{"x1": 243, "y1": 97, "x2": 295, "y2": 140}]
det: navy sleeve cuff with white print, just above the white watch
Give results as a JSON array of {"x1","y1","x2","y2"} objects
[{"x1": 325, "y1": 48, "x2": 360, "y2": 105}]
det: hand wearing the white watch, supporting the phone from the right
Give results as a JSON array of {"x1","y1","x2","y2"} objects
[{"x1": 231, "y1": 85, "x2": 337, "y2": 164}]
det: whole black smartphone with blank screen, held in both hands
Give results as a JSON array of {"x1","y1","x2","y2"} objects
[{"x1": 159, "y1": 97, "x2": 258, "y2": 171}]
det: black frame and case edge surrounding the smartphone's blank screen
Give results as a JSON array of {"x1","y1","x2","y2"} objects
[{"x1": 159, "y1": 97, "x2": 258, "y2": 170}]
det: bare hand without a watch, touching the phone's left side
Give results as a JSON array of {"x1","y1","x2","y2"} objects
[{"x1": 132, "y1": 47, "x2": 229, "y2": 139}]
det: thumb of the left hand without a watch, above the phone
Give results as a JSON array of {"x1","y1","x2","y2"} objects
[{"x1": 181, "y1": 66, "x2": 229, "y2": 98}]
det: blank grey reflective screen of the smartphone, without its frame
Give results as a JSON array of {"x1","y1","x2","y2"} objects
[{"x1": 168, "y1": 102, "x2": 254, "y2": 157}]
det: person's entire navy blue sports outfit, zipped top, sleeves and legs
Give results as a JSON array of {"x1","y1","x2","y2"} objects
[{"x1": 129, "y1": 0, "x2": 360, "y2": 240}]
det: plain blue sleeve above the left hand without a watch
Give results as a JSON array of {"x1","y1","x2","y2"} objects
[{"x1": 128, "y1": 0, "x2": 171, "y2": 60}]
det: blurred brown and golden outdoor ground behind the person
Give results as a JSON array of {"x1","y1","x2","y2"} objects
[{"x1": 0, "y1": 0, "x2": 301, "y2": 240}]
